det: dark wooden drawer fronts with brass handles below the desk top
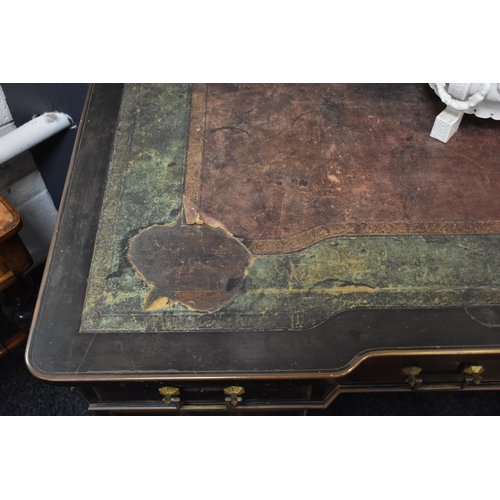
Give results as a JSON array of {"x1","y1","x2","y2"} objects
[{"x1": 75, "y1": 351, "x2": 500, "y2": 414}]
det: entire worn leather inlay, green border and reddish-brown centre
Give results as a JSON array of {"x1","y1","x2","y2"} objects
[{"x1": 81, "y1": 85, "x2": 500, "y2": 332}]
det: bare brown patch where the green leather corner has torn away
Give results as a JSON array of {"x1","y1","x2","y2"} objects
[{"x1": 129, "y1": 222, "x2": 250, "y2": 312}]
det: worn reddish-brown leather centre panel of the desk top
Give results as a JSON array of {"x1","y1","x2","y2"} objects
[{"x1": 190, "y1": 84, "x2": 500, "y2": 253}]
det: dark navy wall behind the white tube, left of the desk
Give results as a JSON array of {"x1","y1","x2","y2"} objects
[{"x1": 0, "y1": 83, "x2": 88, "y2": 208}]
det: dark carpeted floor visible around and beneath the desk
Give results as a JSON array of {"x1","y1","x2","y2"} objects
[{"x1": 0, "y1": 269, "x2": 500, "y2": 416}]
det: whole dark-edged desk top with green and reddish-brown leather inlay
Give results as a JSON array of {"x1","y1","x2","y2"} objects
[{"x1": 27, "y1": 84, "x2": 500, "y2": 381}]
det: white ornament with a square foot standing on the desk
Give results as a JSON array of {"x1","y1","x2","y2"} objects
[{"x1": 429, "y1": 83, "x2": 500, "y2": 142}]
